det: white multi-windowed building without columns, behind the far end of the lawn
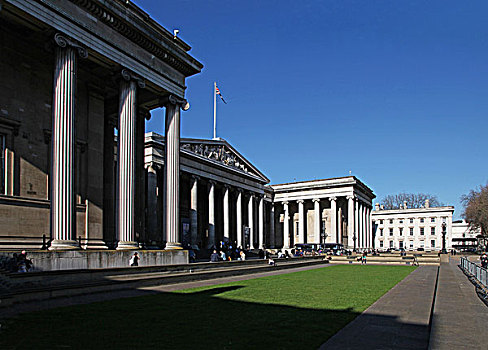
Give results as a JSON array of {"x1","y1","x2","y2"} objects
[{"x1": 371, "y1": 200, "x2": 454, "y2": 251}]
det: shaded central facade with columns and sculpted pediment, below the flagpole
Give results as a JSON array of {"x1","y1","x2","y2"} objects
[{"x1": 145, "y1": 133, "x2": 272, "y2": 249}]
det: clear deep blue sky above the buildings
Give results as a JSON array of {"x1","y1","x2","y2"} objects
[{"x1": 135, "y1": 0, "x2": 488, "y2": 218}]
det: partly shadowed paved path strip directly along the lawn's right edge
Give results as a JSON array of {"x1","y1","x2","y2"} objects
[{"x1": 320, "y1": 266, "x2": 438, "y2": 350}]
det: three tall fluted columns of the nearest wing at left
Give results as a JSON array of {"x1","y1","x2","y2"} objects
[{"x1": 50, "y1": 33, "x2": 188, "y2": 249}]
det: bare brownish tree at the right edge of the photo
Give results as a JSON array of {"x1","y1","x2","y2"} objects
[{"x1": 461, "y1": 184, "x2": 488, "y2": 246}]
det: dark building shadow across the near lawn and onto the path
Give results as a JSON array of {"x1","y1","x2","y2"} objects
[{"x1": 0, "y1": 286, "x2": 428, "y2": 349}]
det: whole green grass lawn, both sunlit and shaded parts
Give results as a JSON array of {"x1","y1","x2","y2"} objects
[{"x1": 0, "y1": 265, "x2": 415, "y2": 350}]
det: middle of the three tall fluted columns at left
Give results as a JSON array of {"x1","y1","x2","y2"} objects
[{"x1": 117, "y1": 69, "x2": 145, "y2": 250}]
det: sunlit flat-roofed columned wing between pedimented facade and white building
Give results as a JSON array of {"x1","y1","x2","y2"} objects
[{"x1": 271, "y1": 176, "x2": 375, "y2": 249}]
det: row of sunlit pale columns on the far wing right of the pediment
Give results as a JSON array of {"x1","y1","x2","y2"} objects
[{"x1": 271, "y1": 196, "x2": 373, "y2": 249}]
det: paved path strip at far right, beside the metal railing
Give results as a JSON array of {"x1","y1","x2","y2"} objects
[{"x1": 429, "y1": 256, "x2": 488, "y2": 350}]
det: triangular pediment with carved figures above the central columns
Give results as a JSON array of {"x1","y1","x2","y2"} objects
[{"x1": 180, "y1": 139, "x2": 269, "y2": 183}]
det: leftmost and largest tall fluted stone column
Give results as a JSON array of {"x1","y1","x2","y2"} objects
[{"x1": 49, "y1": 33, "x2": 87, "y2": 250}]
